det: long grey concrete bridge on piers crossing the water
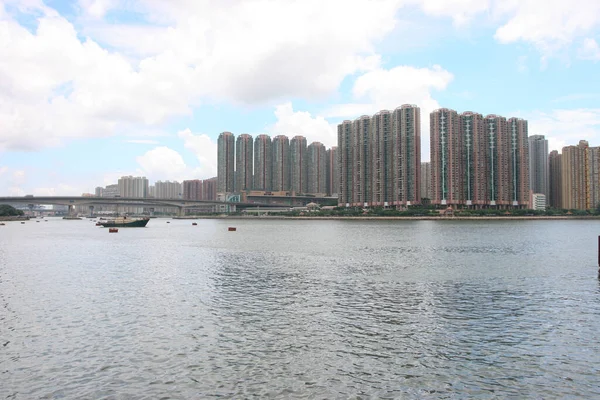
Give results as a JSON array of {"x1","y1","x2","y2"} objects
[{"x1": 0, "y1": 196, "x2": 281, "y2": 216}]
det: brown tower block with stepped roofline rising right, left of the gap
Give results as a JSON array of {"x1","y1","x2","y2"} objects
[{"x1": 338, "y1": 104, "x2": 421, "y2": 207}]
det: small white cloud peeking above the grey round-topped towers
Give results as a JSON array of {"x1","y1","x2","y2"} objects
[{"x1": 268, "y1": 102, "x2": 337, "y2": 147}]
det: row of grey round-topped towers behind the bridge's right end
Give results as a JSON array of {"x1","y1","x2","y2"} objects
[{"x1": 217, "y1": 132, "x2": 339, "y2": 196}]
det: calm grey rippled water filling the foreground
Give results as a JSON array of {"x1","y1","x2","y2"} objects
[{"x1": 0, "y1": 219, "x2": 600, "y2": 399}]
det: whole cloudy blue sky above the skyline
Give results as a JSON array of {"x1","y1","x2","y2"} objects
[{"x1": 0, "y1": 0, "x2": 600, "y2": 196}]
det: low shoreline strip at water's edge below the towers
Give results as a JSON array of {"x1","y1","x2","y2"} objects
[{"x1": 174, "y1": 215, "x2": 600, "y2": 221}]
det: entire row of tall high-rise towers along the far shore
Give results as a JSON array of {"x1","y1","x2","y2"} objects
[{"x1": 217, "y1": 104, "x2": 600, "y2": 210}]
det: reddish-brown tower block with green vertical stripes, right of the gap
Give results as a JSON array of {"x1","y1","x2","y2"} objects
[{"x1": 430, "y1": 108, "x2": 530, "y2": 208}]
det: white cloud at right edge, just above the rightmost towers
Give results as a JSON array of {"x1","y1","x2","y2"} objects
[{"x1": 524, "y1": 108, "x2": 600, "y2": 152}]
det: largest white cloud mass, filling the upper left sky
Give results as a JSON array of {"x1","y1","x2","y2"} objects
[{"x1": 0, "y1": 0, "x2": 400, "y2": 151}]
